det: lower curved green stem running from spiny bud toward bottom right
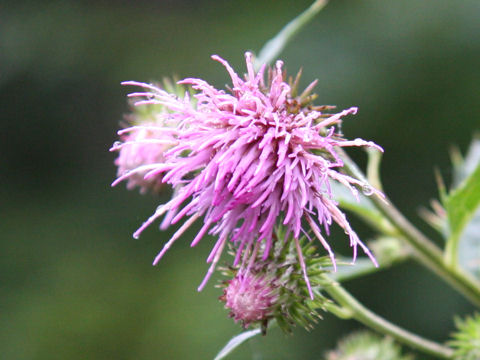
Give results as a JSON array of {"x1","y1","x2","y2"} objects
[{"x1": 324, "y1": 275, "x2": 453, "y2": 359}]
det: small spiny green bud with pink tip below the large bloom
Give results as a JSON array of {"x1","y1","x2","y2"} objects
[{"x1": 220, "y1": 229, "x2": 331, "y2": 333}]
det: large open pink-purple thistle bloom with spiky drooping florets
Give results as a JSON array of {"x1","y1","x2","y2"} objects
[{"x1": 113, "y1": 53, "x2": 381, "y2": 296}]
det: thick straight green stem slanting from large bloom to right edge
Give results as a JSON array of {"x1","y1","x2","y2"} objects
[{"x1": 343, "y1": 152, "x2": 480, "y2": 306}]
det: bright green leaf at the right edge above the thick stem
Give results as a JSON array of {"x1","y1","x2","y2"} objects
[{"x1": 444, "y1": 163, "x2": 480, "y2": 266}]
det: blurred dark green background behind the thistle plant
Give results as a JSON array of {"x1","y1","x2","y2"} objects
[{"x1": 0, "y1": 0, "x2": 480, "y2": 360}]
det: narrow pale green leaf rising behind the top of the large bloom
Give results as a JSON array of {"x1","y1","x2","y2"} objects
[{"x1": 255, "y1": 0, "x2": 328, "y2": 69}]
